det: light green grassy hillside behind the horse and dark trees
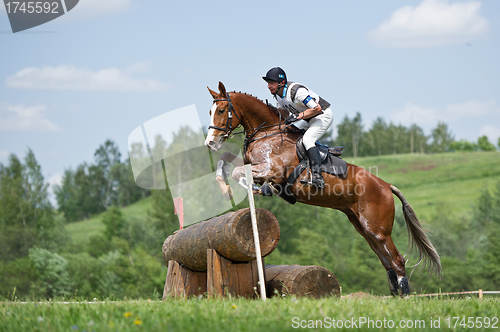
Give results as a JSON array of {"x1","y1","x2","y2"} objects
[{"x1": 66, "y1": 152, "x2": 500, "y2": 243}]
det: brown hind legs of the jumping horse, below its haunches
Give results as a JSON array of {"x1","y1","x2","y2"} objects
[{"x1": 347, "y1": 212, "x2": 410, "y2": 295}]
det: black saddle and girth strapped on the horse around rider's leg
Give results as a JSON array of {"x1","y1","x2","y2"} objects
[{"x1": 261, "y1": 135, "x2": 347, "y2": 204}]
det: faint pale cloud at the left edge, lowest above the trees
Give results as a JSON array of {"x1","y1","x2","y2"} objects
[{"x1": 0, "y1": 104, "x2": 60, "y2": 131}]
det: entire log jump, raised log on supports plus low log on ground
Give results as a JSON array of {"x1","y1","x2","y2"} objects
[{"x1": 162, "y1": 208, "x2": 340, "y2": 299}]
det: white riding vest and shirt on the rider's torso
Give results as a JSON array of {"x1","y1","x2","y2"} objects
[{"x1": 275, "y1": 82, "x2": 330, "y2": 115}]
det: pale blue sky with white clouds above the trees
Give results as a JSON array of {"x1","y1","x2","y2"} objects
[{"x1": 0, "y1": 0, "x2": 500, "y2": 205}]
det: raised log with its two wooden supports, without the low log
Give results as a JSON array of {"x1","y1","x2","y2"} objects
[{"x1": 163, "y1": 209, "x2": 280, "y2": 299}]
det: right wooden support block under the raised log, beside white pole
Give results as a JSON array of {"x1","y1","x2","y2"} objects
[{"x1": 207, "y1": 249, "x2": 259, "y2": 298}]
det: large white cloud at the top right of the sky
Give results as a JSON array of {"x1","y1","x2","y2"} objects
[{"x1": 368, "y1": 0, "x2": 490, "y2": 47}]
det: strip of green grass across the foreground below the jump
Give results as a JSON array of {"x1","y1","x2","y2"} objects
[{"x1": 0, "y1": 297, "x2": 500, "y2": 331}]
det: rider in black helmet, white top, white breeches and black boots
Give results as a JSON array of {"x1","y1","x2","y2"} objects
[{"x1": 262, "y1": 67, "x2": 333, "y2": 188}]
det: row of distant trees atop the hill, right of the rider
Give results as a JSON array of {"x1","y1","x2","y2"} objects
[{"x1": 322, "y1": 112, "x2": 500, "y2": 158}]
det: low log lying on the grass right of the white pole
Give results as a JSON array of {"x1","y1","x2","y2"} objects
[{"x1": 265, "y1": 265, "x2": 340, "y2": 298}]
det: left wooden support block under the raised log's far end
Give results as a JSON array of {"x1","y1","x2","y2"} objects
[{"x1": 163, "y1": 261, "x2": 207, "y2": 300}]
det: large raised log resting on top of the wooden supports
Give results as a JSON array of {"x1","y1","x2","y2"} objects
[{"x1": 163, "y1": 209, "x2": 280, "y2": 271}]
